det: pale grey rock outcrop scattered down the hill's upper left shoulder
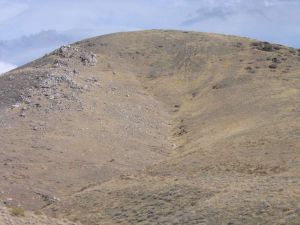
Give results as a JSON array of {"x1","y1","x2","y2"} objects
[{"x1": 13, "y1": 45, "x2": 97, "y2": 114}]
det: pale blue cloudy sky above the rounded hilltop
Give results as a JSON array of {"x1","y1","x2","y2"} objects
[{"x1": 0, "y1": 0, "x2": 300, "y2": 73}]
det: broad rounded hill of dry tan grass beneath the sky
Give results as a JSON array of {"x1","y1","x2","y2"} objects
[{"x1": 0, "y1": 30, "x2": 300, "y2": 225}]
